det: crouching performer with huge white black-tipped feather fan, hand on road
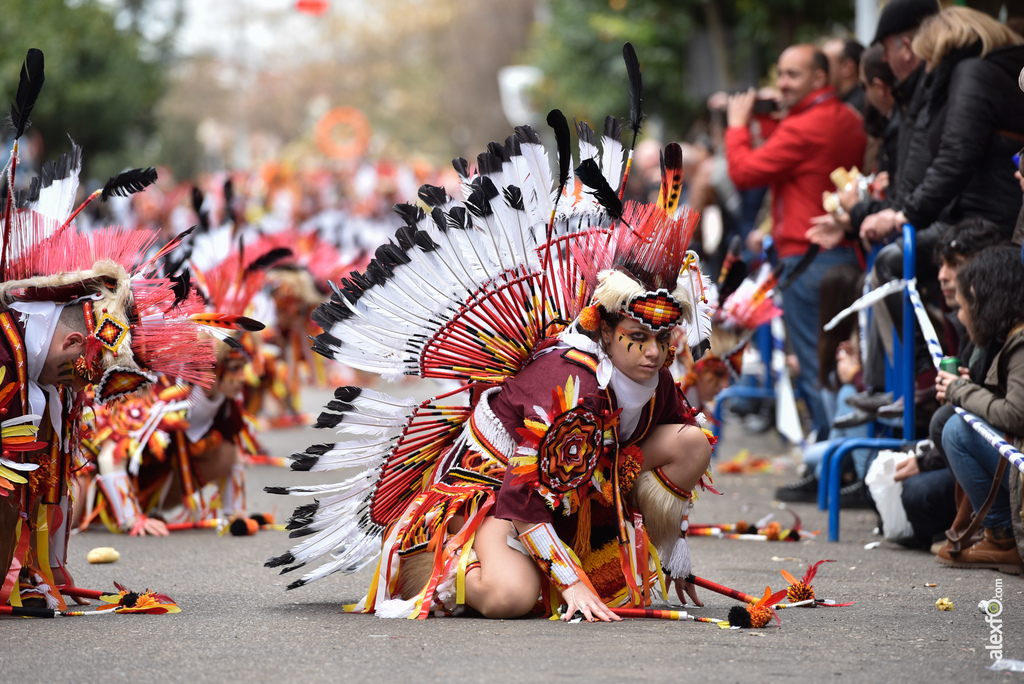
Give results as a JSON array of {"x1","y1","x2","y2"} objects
[{"x1": 267, "y1": 45, "x2": 712, "y2": 619}]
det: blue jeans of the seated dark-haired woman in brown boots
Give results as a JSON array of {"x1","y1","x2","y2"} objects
[{"x1": 942, "y1": 415, "x2": 1011, "y2": 527}]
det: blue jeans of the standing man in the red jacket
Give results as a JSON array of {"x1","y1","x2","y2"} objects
[{"x1": 782, "y1": 247, "x2": 858, "y2": 438}]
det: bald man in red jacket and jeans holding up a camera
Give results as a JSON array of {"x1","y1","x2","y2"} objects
[{"x1": 725, "y1": 45, "x2": 867, "y2": 437}]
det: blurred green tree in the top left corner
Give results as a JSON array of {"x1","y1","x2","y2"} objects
[{"x1": 0, "y1": 0, "x2": 164, "y2": 177}]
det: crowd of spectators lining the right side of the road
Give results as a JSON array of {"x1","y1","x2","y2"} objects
[{"x1": 655, "y1": 0, "x2": 1024, "y2": 574}]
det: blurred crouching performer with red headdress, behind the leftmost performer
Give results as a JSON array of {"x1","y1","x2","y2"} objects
[{"x1": 79, "y1": 241, "x2": 272, "y2": 536}]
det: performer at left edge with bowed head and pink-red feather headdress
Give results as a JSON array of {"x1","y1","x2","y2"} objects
[{"x1": 0, "y1": 49, "x2": 213, "y2": 608}]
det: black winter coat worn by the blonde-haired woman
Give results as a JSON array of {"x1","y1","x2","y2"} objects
[{"x1": 894, "y1": 44, "x2": 1024, "y2": 238}]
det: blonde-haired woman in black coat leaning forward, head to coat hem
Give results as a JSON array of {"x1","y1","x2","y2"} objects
[{"x1": 896, "y1": 7, "x2": 1024, "y2": 239}]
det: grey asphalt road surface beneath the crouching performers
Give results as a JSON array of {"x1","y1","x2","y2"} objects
[{"x1": 0, "y1": 386, "x2": 1024, "y2": 682}]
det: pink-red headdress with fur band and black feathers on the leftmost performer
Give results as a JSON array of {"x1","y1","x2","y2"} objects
[{"x1": 0, "y1": 49, "x2": 220, "y2": 402}]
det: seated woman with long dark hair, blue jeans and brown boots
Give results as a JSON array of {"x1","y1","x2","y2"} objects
[{"x1": 936, "y1": 247, "x2": 1024, "y2": 574}]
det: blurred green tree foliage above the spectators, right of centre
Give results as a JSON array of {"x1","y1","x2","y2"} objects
[{"x1": 529, "y1": 0, "x2": 854, "y2": 139}]
